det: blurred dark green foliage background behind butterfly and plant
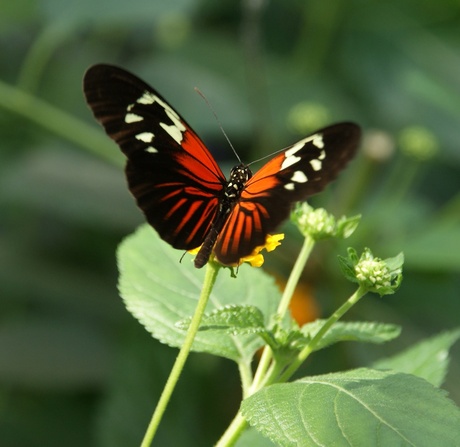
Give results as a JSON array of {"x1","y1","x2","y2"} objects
[{"x1": 0, "y1": 0, "x2": 460, "y2": 447}]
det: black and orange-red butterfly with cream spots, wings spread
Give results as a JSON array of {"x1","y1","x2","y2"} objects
[{"x1": 83, "y1": 64, "x2": 361, "y2": 268}]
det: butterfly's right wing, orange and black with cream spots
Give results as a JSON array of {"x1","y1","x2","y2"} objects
[{"x1": 214, "y1": 123, "x2": 361, "y2": 265}]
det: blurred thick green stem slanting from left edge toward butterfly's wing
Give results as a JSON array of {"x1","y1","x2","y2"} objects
[{"x1": 0, "y1": 81, "x2": 123, "y2": 166}]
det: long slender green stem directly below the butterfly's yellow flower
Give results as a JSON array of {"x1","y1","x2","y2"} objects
[{"x1": 141, "y1": 261, "x2": 220, "y2": 447}]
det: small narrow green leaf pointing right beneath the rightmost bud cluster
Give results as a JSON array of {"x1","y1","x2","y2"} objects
[{"x1": 301, "y1": 320, "x2": 401, "y2": 350}]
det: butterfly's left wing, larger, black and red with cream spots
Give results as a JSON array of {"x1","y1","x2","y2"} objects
[{"x1": 83, "y1": 64, "x2": 225, "y2": 250}]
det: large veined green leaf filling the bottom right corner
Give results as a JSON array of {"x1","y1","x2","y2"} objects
[{"x1": 242, "y1": 369, "x2": 460, "y2": 447}]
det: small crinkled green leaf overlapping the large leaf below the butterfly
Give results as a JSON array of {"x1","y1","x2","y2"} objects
[{"x1": 176, "y1": 304, "x2": 266, "y2": 335}]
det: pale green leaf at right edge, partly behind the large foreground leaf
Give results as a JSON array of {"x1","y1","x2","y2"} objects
[{"x1": 372, "y1": 329, "x2": 460, "y2": 386}]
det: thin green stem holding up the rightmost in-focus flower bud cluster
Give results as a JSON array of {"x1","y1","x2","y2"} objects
[{"x1": 279, "y1": 286, "x2": 367, "y2": 382}]
